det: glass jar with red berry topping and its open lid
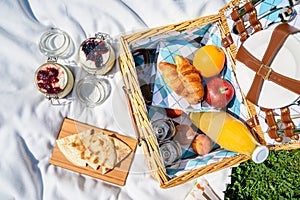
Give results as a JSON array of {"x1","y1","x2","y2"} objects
[{"x1": 34, "y1": 28, "x2": 74, "y2": 102}]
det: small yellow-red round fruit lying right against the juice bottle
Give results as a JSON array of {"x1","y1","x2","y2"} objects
[{"x1": 192, "y1": 134, "x2": 213, "y2": 155}]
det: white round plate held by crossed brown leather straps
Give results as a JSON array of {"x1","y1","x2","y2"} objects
[{"x1": 236, "y1": 30, "x2": 300, "y2": 109}]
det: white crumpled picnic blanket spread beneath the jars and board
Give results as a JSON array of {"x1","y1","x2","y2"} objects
[{"x1": 0, "y1": 0, "x2": 226, "y2": 200}]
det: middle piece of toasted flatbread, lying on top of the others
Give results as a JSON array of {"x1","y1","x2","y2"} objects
[{"x1": 78, "y1": 129, "x2": 117, "y2": 174}]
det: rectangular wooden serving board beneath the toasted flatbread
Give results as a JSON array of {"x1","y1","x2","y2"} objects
[{"x1": 50, "y1": 118, "x2": 137, "y2": 186}]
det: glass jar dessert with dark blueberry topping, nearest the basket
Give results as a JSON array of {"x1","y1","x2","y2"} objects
[{"x1": 78, "y1": 33, "x2": 116, "y2": 75}]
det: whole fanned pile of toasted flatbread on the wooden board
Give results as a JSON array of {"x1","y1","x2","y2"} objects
[{"x1": 57, "y1": 129, "x2": 131, "y2": 174}]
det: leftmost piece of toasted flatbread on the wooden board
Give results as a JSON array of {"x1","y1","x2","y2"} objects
[{"x1": 56, "y1": 134, "x2": 87, "y2": 167}]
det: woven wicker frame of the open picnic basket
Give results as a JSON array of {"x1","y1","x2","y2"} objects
[{"x1": 119, "y1": 0, "x2": 300, "y2": 188}]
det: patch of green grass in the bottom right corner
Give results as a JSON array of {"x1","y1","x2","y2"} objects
[{"x1": 225, "y1": 149, "x2": 300, "y2": 199}]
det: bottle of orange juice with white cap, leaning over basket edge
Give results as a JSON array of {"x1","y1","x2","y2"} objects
[{"x1": 190, "y1": 111, "x2": 269, "y2": 163}]
